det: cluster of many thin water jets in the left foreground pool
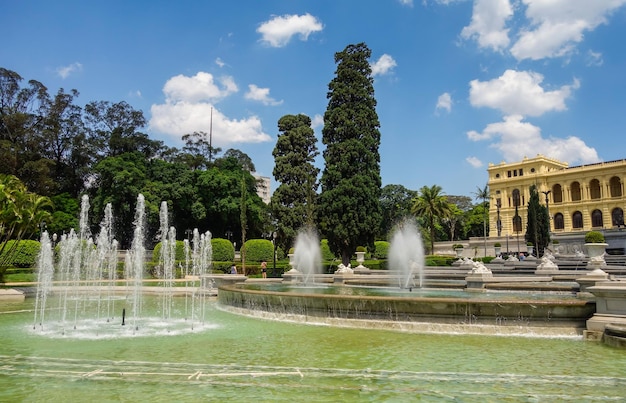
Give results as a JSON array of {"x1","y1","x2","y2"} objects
[{"x1": 33, "y1": 195, "x2": 211, "y2": 338}]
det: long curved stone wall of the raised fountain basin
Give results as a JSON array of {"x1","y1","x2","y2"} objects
[{"x1": 218, "y1": 284, "x2": 595, "y2": 335}]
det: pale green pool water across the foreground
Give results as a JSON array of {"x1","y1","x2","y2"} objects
[{"x1": 0, "y1": 300, "x2": 626, "y2": 402}]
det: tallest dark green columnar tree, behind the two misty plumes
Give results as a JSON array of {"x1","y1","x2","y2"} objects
[{"x1": 319, "y1": 43, "x2": 382, "y2": 265}]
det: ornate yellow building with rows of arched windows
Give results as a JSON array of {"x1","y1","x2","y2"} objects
[{"x1": 487, "y1": 155, "x2": 626, "y2": 238}]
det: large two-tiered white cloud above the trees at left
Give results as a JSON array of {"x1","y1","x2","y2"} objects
[{"x1": 150, "y1": 72, "x2": 271, "y2": 147}]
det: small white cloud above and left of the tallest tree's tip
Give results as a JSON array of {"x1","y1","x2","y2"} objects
[{"x1": 257, "y1": 13, "x2": 324, "y2": 48}]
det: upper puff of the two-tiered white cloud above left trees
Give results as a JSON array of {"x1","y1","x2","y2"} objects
[{"x1": 163, "y1": 71, "x2": 238, "y2": 102}]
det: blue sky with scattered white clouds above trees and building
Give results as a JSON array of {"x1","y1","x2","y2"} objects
[{"x1": 0, "y1": 0, "x2": 626, "y2": 196}]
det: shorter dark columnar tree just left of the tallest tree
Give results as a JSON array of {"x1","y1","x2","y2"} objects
[{"x1": 271, "y1": 115, "x2": 320, "y2": 250}]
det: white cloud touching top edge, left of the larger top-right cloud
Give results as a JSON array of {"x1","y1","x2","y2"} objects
[{"x1": 461, "y1": 0, "x2": 513, "y2": 51}]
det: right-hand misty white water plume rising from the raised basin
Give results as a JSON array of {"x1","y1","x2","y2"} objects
[{"x1": 389, "y1": 220, "x2": 424, "y2": 288}]
